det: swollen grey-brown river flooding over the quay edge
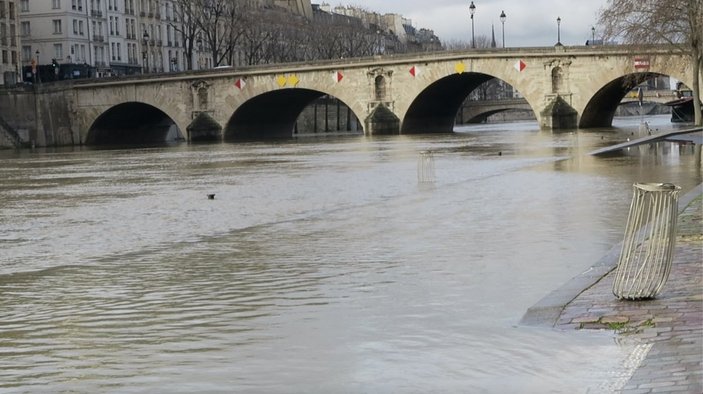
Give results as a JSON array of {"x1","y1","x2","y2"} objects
[{"x1": 0, "y1": 117, "x2": 702, "y2": 393}]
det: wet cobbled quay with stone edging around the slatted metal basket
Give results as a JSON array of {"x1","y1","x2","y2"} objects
[{"x1": 523, "y1": 185, "x2": 703, "y2": 394}]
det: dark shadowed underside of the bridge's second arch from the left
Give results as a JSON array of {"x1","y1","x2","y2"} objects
[{"x1": 224, "y1": 88, "x2": 359, "y2": 141}]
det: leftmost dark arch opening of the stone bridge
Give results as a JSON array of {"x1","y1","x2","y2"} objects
[{"x1": 85, "y1": 101, "x2": 185, "y2": 145}]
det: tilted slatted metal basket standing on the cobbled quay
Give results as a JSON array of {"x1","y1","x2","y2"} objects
[{"x1": 613, "y1": 183, "x2": 681, "y2": 300}]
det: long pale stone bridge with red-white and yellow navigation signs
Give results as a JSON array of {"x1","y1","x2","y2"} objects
[{"x1": 70, "y1": 46, "x2": 693, "y2": 144}]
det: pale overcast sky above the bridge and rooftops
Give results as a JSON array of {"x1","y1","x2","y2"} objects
[{"x1": 336, "y1": 0, "x2": 607, "y2": 47}]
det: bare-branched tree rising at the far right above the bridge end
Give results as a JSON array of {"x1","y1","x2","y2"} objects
[{"x1": 598, "y1": 0, "x2": 703, "y2": 126}]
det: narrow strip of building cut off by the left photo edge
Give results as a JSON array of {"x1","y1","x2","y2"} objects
[{"x1": 0, "y1": 0, "x2": 20, "y2": 85}]
